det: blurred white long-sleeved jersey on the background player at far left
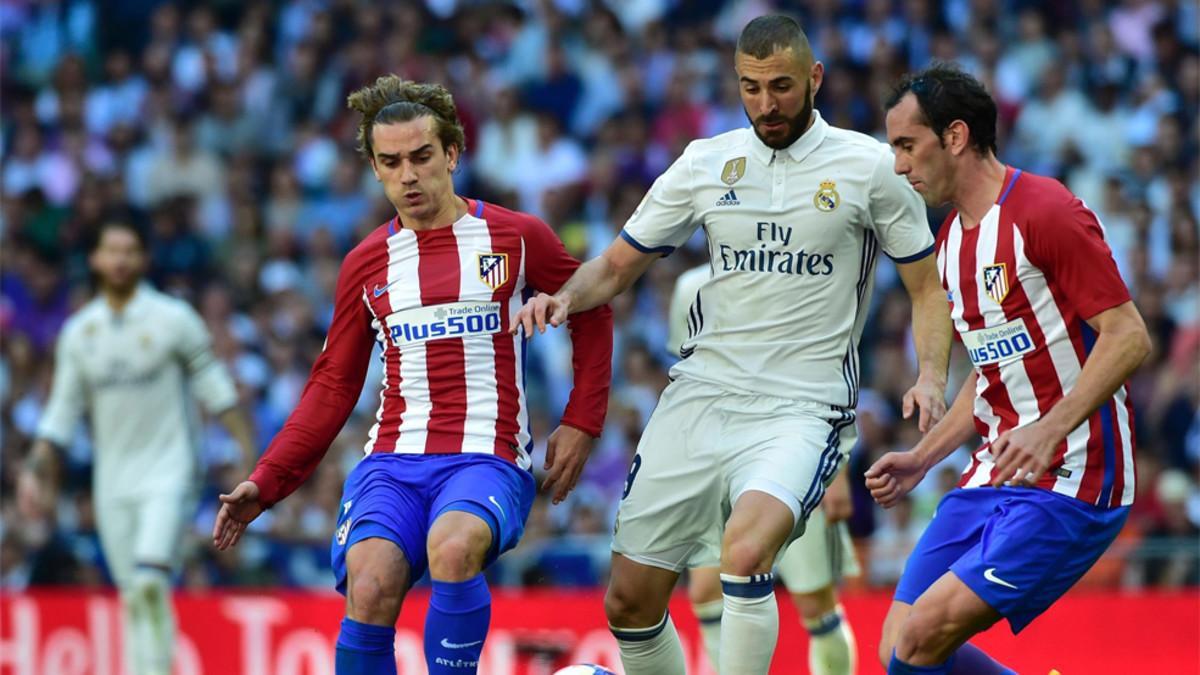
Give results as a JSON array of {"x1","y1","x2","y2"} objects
[{"x1": 37, "y1": 285, "x2": 238, "y2": 498}]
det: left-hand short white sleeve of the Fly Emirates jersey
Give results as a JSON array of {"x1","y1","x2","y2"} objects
[{"x1": 620, "y1": 145, "x2": 700, "y2": 256}]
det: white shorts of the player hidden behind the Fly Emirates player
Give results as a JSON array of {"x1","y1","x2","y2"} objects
[{"x1": 775, "y1": 507, "x2": 862, "y2": 593}]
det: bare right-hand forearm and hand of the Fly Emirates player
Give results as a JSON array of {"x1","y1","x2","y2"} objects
[{"x1": 896, "y1": 256, "x2": 953, "y2": 431}]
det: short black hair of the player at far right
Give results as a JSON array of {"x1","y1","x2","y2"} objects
[{"x1": 883, "y1": 61, "x2": 996, "y2": 155}]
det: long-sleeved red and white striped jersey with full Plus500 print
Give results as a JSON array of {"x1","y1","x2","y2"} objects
[{"x1": 251, "y1": 199, "x2": 612, "y2": 504}]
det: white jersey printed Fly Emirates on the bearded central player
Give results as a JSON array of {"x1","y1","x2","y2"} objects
[{"x1": 622, "y1": 110, "x2": 934, "y2": 407}]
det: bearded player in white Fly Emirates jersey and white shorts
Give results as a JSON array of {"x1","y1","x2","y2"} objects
[{"x1": 521, "y1": 16, "x2": 949, "y2": 675}]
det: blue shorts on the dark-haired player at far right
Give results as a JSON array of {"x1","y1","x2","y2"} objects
[{"x1": 895, "y1": 486, "x2": 1129, "y2": 634}]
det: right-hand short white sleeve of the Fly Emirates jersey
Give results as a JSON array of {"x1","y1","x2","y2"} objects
[{"x1": 868, "y1": 151, "x2": 934, "y2": 264}]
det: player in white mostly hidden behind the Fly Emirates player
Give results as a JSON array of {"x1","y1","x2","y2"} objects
[{"x1": 667, "y1": 263, "x2": 860, "y2": 675}]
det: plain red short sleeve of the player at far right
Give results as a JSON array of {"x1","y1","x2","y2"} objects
[{"x1": 1026, "y1": 192, "x2": 1130, "y2": 319}]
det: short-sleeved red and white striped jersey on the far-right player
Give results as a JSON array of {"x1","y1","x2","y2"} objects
[{"x1": 937, "y1": 168, "x2": 1134, "y2": 507}]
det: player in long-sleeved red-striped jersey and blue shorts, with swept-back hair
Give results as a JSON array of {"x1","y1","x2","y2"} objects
[{"x1": 214, "y1": 76, "x2": 612, "y2": 675}]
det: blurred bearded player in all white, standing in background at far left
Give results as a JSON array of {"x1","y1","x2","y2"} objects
[{"x1": 18, "y1": 221, "x2": 254, "y2": 675}]
